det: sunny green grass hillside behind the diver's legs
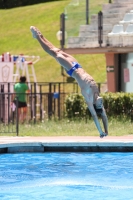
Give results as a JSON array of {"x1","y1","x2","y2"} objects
[{"x1": 0, "y1": 0, "x2": 107, "y2": 82}]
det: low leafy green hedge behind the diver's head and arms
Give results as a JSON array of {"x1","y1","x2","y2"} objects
[{"x1": 65, "y1": 92, "x2": 133, "y2": 118}]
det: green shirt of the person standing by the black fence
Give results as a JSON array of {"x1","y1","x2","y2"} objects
[{"x1": 14, "y1": 83, "x2": 29, "y2": 102}]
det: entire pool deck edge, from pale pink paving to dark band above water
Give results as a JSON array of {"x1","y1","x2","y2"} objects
[{"x1": 0, "y1": 135, "x2": 133, "y2": 153}]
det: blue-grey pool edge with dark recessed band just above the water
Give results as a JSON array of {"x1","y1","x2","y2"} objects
[{"x1": 0, "y1": 141, "x2": 133, "y2": 153}]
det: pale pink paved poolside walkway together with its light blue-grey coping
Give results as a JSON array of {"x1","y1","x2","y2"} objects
[{"x1": 0, "y1": 135, "x2": 133, "y2": 148}]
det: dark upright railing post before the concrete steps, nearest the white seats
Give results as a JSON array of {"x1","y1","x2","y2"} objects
[{"x1": 98, "y1": 11, "x2": 103, "y2": 47}]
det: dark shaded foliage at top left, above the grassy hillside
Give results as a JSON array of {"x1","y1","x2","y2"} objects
[{"x1": 0, "y1": 0, "x2": 61, "y2": 9}]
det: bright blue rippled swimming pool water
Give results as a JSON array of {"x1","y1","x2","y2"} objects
[{"x1": 0, "y1": 153, "x2": 133, "y2": 200}]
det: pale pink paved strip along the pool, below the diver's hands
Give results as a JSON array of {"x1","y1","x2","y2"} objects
[{"x1": 0, "y1": 135, "x2": 133, "y2": 145}]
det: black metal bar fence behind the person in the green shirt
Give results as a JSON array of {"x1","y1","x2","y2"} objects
[{"x1": 0, "y1": 82, "x2": 106, "y2": 135}]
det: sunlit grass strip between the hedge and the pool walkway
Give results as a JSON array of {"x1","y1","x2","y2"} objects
[{"x1": 0, "y1": 118, "x2": 133, "y2": 137}]
